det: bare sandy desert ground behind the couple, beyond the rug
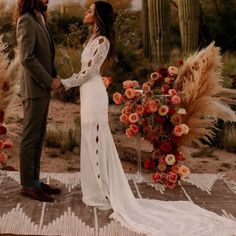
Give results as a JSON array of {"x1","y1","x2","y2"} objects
[{"x1": 2, "y1": 92, "x2": 236, "y2": 181}]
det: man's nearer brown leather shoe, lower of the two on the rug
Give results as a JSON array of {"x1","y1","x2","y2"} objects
[{"x1": 21, "y1": 187, "x2": 54, "y2": 202}]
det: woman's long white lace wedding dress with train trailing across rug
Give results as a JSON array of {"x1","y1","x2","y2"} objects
[{"x1": 62, "y1": 36, "x2": 236, "y2": 236}]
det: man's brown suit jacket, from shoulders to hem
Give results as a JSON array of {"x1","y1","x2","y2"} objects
[{"x1": 16, "y1": 13, "x2": 56, "y2": 99}]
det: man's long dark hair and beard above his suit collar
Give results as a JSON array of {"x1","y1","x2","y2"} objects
[{"x1": 13, "y1": 0, "x2": 46, "y2": 27}]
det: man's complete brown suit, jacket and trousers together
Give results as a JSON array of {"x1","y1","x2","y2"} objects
[{"x1": 16, "y1": 13, "x2": 56, "y2": 187}]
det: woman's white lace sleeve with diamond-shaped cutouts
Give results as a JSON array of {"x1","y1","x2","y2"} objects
[{"x1": 61, "y1": 36, "x2": 110, "y2": 90}]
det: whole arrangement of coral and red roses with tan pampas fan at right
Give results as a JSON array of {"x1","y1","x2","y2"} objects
[{"x1": 113, "y1": 43, "x2": 236, "y2": 188}]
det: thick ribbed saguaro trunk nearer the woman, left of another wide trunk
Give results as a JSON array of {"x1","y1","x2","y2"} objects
[{"x1": 148, "y1": 0, "x2": 170, "y2": 64}]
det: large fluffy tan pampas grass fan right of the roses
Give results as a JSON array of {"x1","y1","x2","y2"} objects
[{"x1": 175, "y1": 43, "x2": 236, "y2": 145}]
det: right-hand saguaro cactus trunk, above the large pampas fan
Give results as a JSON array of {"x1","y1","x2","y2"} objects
[{"x1": 178, "y1": 0, "x2": 200, "y2": 55}]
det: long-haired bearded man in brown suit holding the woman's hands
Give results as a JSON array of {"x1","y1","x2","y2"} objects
[{"x1": 15, "y1": 0, "x2": 60, "y2": 202}]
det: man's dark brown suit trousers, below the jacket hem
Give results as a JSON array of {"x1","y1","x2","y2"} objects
[{"x1": 20, "y1": 95, "x2": 50, "y2": 188}]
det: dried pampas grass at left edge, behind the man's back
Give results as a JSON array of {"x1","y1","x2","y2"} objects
[{"x1": 0, "y1": 38, "x2": 19, "y2": 111}]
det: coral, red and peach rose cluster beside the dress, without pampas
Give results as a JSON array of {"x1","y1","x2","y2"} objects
[{"x1": 113, "y1": 66, "x2": 189, "y2": 188}]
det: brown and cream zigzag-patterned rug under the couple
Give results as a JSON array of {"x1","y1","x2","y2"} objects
[{"x1": 0, "y1": 171, "x2": 236, "y2": 236}]
